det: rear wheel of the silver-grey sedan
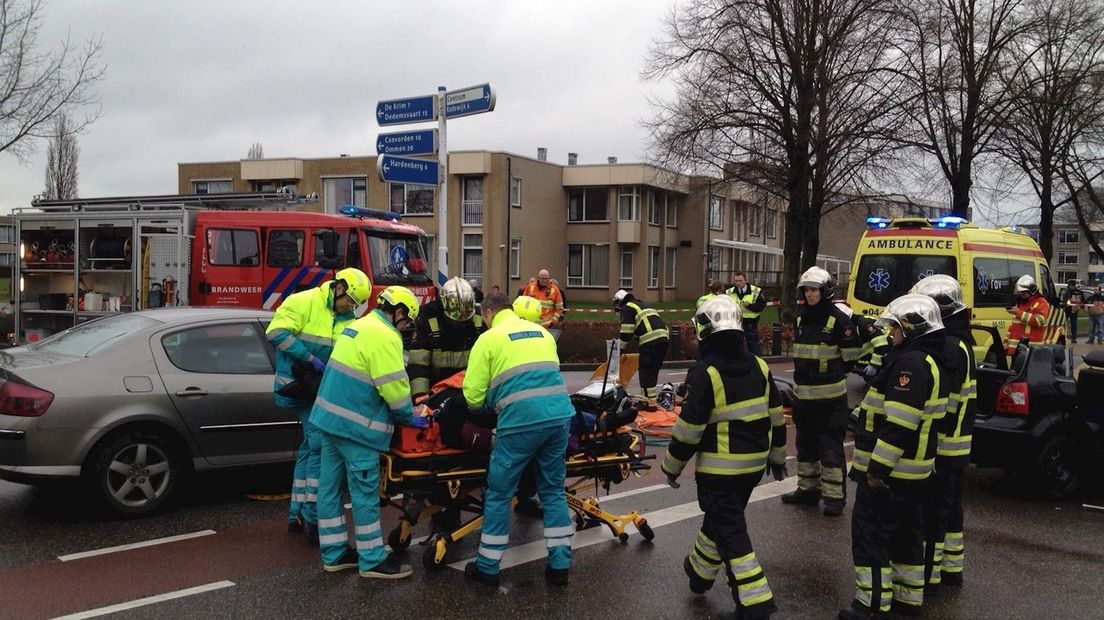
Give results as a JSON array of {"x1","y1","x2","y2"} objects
[{"x1": 88, "y1": 430, "x2": 181, "y2": 516}]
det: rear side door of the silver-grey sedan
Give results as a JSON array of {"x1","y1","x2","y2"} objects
[{"x1": 150, "y1": 319, "x2": 299, "y2": 464}]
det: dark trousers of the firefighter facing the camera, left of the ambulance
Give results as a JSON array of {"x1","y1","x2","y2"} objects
[{"x1": 794, "y1": 396, "x2": 849, "y2": 502}]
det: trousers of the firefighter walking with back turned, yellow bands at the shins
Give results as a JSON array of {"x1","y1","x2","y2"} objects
[{"x1": 689, "y1": 473, "x2": 777, "y2": 620}]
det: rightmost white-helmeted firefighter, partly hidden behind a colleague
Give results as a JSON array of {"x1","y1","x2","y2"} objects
[{"x1": 912, "y1": 276, "x2": 977, "y2": 589}]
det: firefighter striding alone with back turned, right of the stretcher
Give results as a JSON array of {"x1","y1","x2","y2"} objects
[{"x1": 660, "y1": 296, "x2": 786, "y2": 620}]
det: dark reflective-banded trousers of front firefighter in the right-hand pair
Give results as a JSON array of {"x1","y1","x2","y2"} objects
[{"x1": 851, "y1": 470, "x2": 924, "y2": 612}]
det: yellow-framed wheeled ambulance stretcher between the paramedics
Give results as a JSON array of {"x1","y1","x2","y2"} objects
[{"x1": 380, "y1": 427, "x2": 655, "y2": 568}]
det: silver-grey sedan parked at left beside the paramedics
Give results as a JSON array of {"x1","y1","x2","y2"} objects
[{"x1": 0, "y1": 308, "x2": 299, "y2": 515}]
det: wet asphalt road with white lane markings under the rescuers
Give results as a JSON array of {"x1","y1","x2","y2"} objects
[{"x1": 0, "y1": 366, "x2": 1104, "y2": 619}]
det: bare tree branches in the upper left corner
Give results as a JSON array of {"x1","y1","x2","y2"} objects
[{"x1": 0, "y1": 0, "x2": 104, "y2": 161}]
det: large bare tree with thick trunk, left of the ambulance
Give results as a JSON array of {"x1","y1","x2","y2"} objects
[{"x1": 645, "y1": 0, "x2": 901, "y2": 320}]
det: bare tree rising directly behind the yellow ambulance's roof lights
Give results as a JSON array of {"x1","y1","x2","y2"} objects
[{"x1": 898, "y1": 0, "x2": 1027, "y2": 217}]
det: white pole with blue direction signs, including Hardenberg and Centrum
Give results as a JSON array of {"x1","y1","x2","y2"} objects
[{"x1": 375, "y1": 84, "x2": 495, "y2": 285}]
